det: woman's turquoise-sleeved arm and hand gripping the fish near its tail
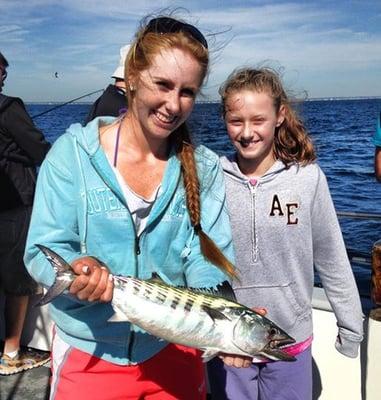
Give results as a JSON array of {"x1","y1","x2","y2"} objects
[{"x1": 24, "y1": 135, "x2": 113, "y2": 301}]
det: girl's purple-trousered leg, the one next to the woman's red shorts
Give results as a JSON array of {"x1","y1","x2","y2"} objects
[{"x1": 208, "y1": 357, "x2": 258, "y2": 400}]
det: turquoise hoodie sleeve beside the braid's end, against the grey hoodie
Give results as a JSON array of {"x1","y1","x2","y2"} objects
[{"x1": 185, "y1": 149, "x2": 234, "y2": 287}]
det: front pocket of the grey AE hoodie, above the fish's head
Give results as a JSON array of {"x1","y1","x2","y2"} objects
[{"x1": 234, "y1": 282, "x2": 310, "y2": 332}]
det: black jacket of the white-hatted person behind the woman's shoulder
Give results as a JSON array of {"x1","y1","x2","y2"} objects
[{"x1": 85, "y1": 85, "x2": 127, "y2": 125}]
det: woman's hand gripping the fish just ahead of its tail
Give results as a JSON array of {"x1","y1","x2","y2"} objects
[{"x1": 69, "y1": 257, "x2": 114, "y2": 303}]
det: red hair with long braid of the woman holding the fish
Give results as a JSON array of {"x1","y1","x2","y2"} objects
[{"x1": 124, "y1": 20, "x2": 236, "y2": 277}]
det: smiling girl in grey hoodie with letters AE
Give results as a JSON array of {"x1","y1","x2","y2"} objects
[{"x1": 209, "y1": 68, "x2": 363, "y2": 400}]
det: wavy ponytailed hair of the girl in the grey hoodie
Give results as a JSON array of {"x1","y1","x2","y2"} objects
[{"x1": 219, "y1": 67, "x2": 316, "y2": 166}]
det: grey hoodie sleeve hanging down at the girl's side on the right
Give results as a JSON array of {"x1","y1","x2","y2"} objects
[{"x1": 312, "y1": 168, "x2": 363, "y2": 357}]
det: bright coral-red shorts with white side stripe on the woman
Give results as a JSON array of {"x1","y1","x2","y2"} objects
[{"x1": 50, "y1": 335, "x2": 206, "y2": 400}]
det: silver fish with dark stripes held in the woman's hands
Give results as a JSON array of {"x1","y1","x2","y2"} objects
[{"x1": 36, "y1": 245, "x2": 295, "y2": 362}]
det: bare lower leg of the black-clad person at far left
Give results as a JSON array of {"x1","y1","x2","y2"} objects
[{"x1": 4, "y1": 294, "x2": 29, "y2": 356}]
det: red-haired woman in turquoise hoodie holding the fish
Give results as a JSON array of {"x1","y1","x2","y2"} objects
[{"x1": 25, "y1": 17, "x2": 233, "y2": 400}]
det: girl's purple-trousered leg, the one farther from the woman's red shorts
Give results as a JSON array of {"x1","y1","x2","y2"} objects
[{"x1": 258, "y1": 346, "x2": 312, "y2": 400}]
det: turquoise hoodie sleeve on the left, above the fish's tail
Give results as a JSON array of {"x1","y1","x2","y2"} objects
[{"x1": 24, "y1": 135, "x2": 81, "y2": 287}]
